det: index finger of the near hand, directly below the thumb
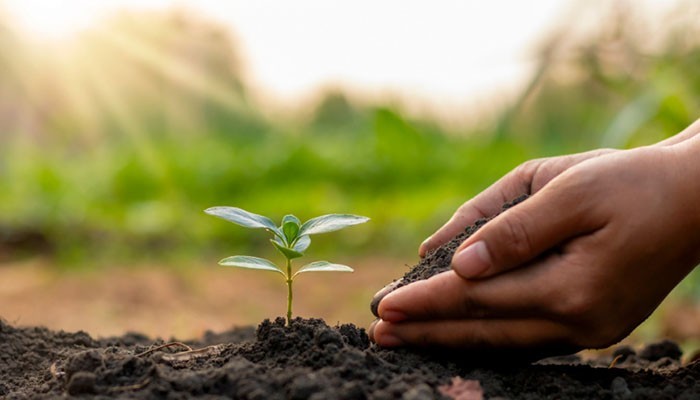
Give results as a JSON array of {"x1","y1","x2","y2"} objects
[{"x1": 377, "y1": 266, "x2": 551, "y2": 322}]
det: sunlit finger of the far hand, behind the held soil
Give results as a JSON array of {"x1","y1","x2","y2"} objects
[{"x1": 418, "y1": 172, "x2": 529, "y2": 257}]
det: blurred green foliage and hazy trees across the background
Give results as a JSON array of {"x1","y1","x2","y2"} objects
[{"x1": 0, "y1": 3, "x2": 700, "y2": 263}]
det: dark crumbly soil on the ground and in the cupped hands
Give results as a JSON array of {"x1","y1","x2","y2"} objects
[{"x1": 0, "y1": 198, "x2": 700, "y2": 400}]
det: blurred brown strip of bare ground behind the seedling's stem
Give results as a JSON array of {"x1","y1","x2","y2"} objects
[{"x1": 0, "y1": 254, "x2": 400, "y2": 339}]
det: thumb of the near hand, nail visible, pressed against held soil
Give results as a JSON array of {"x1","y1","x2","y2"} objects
[{"x1": 452, "y1": 189, "x2": 600, "y2": 279}]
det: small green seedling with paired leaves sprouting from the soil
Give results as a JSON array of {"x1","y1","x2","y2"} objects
[{"x1": 204, "y1": 207, "x2": 369, "y2": 325}]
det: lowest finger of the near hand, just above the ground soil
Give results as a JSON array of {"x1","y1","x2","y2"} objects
[{"x1": 372, "y1": 319, "x2": 573, "y2": 350}]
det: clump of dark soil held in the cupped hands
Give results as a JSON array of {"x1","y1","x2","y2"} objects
[{"x1": 370, "y1": 194, "x2": 529, "y2": 316}]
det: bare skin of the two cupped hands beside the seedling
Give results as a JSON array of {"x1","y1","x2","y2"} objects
[{"x1": 370, "y1": 120, "x2": 700, "y2": 355}]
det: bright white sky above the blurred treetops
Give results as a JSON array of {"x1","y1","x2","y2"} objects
[{"x1": 0, "y1": 0, "x2": 688, "y2": 121}]
